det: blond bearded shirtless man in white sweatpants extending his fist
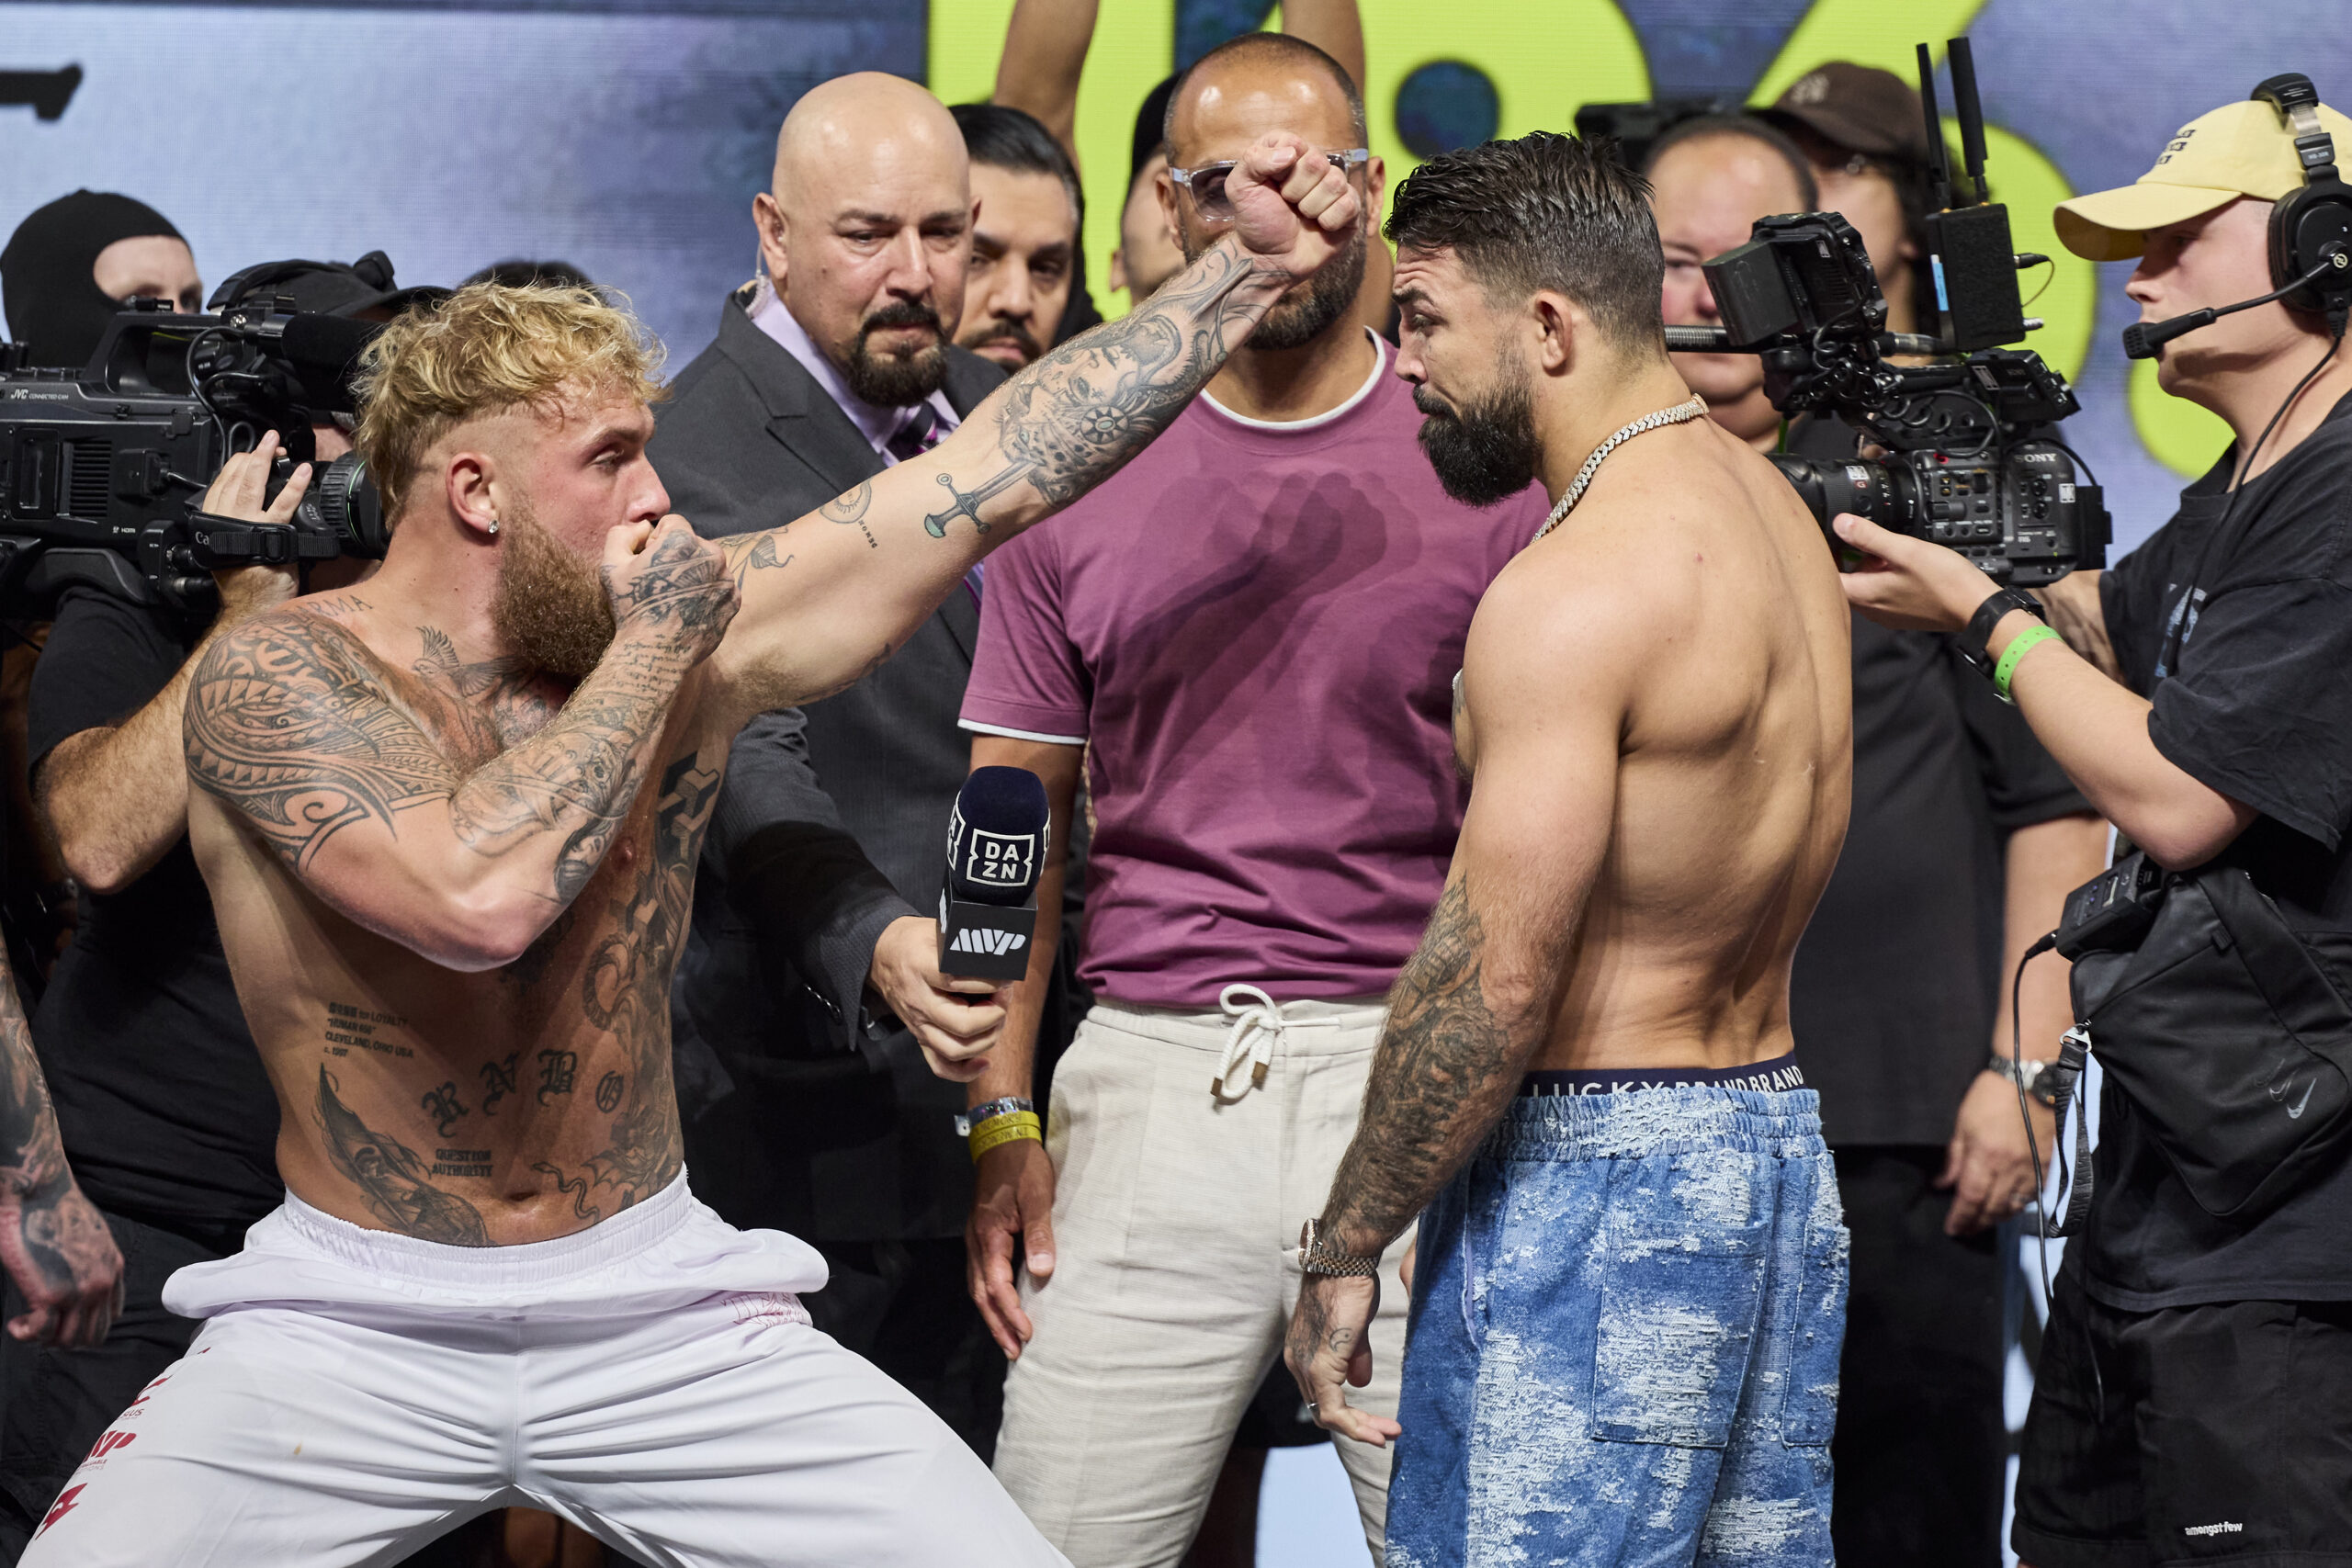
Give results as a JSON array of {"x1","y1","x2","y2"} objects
[{"x1": 24, "y1": 136, "x2": 1355, "y2": 1568}]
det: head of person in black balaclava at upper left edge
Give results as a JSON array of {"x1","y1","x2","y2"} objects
[{"x1": 0, "y1": 190, "x2": 205, "y2": 369}]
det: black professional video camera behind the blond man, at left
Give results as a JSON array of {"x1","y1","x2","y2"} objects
[{"x1": 0, "y1": 299, "x2": 386, "y2": 616}]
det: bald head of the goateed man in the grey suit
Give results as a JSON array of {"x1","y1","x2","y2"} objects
[{"x1": 752, "y1": 71, "x2": 971, "y2": 407}]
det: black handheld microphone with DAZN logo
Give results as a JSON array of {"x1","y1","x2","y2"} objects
[{"x1": 938, "y1": 769, "x2": 1049, "y2": 980}]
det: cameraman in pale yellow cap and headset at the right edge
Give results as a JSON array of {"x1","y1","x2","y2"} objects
[{"x1": 1837, "y1": 88, "x2": 2352, "y2": 1568}]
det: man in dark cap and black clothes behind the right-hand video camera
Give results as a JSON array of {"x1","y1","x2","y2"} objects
[{"x1": 1746, "y1": 62, "x2": 2108, "y2": 1568}]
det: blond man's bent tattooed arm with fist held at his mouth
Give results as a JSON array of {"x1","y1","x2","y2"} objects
[{"x1": 184, "y1": 517, "x2": 734, "y2": 971}]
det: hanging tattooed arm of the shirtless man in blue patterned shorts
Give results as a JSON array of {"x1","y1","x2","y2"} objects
[{"x1": 1284, "y1": 559, "x2": 1646, "y2": 1443}]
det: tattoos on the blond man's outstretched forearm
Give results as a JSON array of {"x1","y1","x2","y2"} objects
[{"x1": 922, "y1": 244, "x2": 1261, "y2": 538}]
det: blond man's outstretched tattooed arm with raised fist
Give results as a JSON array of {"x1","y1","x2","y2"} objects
[{"x1": 713, "y1": 136, "x2": 1357, "y2": 719}]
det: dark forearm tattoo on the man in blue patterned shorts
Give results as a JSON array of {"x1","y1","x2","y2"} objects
[{"x1": 1322, "y1": 877, "x2": 1543, "y2": 1246}]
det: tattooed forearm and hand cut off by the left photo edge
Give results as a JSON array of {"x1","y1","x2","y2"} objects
[{"x1": 0, "y1": 944, "x2": 122, "y2": 1349}]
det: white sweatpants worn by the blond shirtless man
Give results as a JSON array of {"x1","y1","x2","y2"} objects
[{"x1": 24, "y1": 1178, "x2": 1063, "y2": 1568}]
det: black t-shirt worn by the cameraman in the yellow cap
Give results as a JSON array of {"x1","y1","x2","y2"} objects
[{"x1": 2070, "y1": 385, "x2": 2352, "y2": 1312}]
